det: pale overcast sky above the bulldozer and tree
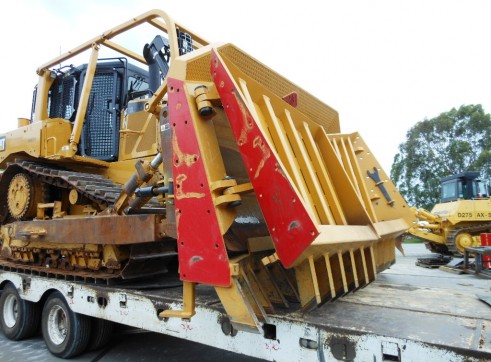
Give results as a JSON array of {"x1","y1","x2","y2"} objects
[{"x1": 0, "y1": 0, "x2": 491, "y2": 172}]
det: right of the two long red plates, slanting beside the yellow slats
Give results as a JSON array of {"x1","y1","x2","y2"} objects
[{"x1": 211, "y1": 50, "x2": 319, "y2": 267}]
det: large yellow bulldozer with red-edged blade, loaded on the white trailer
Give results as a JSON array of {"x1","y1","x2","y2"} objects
[{"x1": 0, "y1": 10, "x2": 413, "y2": 331}]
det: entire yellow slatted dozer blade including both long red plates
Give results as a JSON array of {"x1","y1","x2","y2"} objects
[{"x1": 168, "y1": 44, "x2": 414, "y2": 331}]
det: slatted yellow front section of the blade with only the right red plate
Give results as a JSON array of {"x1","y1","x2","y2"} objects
[{"x1": 211, "y1": 45, "x2": 413, "y2": 306}]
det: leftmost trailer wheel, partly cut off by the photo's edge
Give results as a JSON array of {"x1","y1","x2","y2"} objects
[{"x1": 0, "y1": 283, "x2": 40, "y2": 341}]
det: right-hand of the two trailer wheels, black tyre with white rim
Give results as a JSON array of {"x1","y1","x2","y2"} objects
[{"x1": 41, "y1": 292, "x2": 91, "y2": 358}]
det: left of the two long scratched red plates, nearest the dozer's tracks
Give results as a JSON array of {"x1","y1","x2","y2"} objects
[{"x1": 168, "y1": 78, "x2": 230, "y2": 286}]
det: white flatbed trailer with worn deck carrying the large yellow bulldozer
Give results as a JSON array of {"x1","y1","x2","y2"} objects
[{"x1": 0, "y1": 245, "x2": 491, "y2": 361}]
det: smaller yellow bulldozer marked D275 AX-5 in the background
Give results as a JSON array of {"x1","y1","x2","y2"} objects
[{"x1": 409, "y1": 171, "x2": 491, "y2": 256}]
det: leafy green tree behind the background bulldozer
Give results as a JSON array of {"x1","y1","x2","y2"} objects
[{"x1": 391, "y1": 104, "x2": 491, "y2": 210}]
